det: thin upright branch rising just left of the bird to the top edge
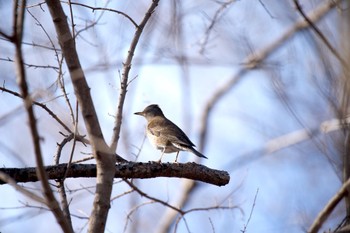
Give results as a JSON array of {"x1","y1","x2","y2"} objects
[{"x1": 111, "y1": 0, "x2": 159, "y2": 152}]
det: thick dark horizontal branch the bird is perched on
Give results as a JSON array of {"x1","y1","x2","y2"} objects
[{"x1": 0, "y1": 162, "x2": 230, "y2": 186}]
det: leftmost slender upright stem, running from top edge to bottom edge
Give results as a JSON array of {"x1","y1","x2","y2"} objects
[{"x1": 13, "y1": 0, "x2": 73, "y2": 232}]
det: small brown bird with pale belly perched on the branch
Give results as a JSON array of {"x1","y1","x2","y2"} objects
[{"x1": 134, "y1": 104, "x2": 208, "y2": 163}]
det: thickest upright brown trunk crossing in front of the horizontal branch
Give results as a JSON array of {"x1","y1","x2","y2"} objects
[{"x1": 46, "y1": 0, "x2": 116, "y2": 232}]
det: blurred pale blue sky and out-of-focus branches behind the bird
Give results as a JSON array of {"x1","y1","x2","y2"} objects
[{"x1": 0, "y1": 0, "x2": 350, "y2": 233}]
